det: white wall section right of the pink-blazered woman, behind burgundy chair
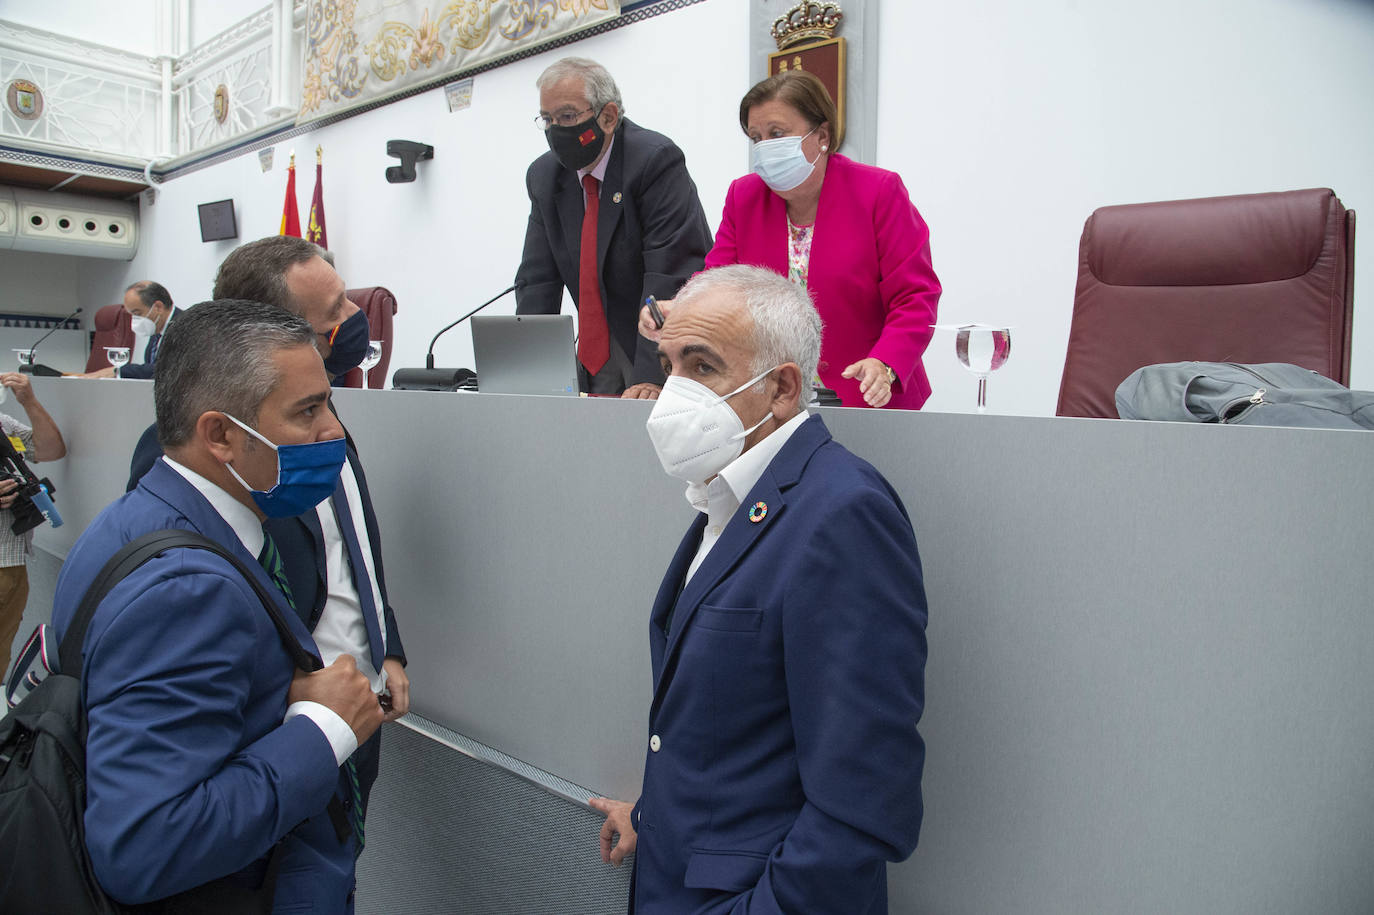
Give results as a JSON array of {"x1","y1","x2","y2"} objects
[{"x1": 878, "y1": 0, "x2": 1374, "y2": 415}]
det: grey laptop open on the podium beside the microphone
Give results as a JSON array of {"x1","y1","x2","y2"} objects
[{"x1": 473, "y1": 315, "x2": 577, "y2": 397}]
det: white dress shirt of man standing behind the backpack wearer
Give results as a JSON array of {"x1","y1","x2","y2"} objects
[{"x1": 313, "y1": 460, "x2": 386, "y2": 692}]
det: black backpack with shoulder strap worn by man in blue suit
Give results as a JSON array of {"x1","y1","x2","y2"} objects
[{"x1": 0, "y1": 529, "x2": 320, "y2": 915}]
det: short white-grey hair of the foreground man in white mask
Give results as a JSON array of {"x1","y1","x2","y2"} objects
[{"x1": 673, "y1": 264, "x2": 820, "y2": 392}]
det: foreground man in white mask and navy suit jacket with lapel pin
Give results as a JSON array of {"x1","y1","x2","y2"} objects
[{"x1": 591, "y1": 267, "x2": 926, "y2": 915}]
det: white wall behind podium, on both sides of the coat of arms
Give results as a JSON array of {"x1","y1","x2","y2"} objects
[{"x1": 16, "y1": 0, "x2": 1374, "y2": 415}]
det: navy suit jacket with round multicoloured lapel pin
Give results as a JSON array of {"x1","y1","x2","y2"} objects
[{"x1": 631, "y1": 416, "x2": 926, "y2": 915}]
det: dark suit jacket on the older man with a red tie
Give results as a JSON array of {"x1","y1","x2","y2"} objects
[{"x1": 515, "y1": 118, "x2": 712, "y2": 385}]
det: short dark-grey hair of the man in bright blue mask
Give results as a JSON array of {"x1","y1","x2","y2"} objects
[{"x1": 153, "y1": 298, "x2": 315, "y2": 449}]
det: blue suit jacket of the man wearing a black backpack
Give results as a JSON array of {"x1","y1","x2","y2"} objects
[{"x1": 52, "y1": 463, "x2": 353, "y2": 904}]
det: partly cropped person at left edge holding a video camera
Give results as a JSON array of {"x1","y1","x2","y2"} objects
[{"x1": 0, "y1": 372, "x2": 67, "y2": 672}]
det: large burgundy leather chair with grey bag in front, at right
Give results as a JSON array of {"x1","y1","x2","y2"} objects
[{"x1": 1055, "y1": 188, "x2": 1355, "y2": 419}]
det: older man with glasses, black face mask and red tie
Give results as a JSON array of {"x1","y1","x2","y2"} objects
[{"x1": 515, "y1": 58, "x2": 712, "y2": 398}]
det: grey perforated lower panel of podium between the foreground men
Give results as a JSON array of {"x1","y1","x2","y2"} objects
[{"x1": 356, "y1": 720, "x2": 629, "y2": 915}]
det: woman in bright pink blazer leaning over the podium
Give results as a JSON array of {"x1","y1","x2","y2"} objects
[{"x1": 706, "y1": 70, "x2": 940, "y2": 409}]
